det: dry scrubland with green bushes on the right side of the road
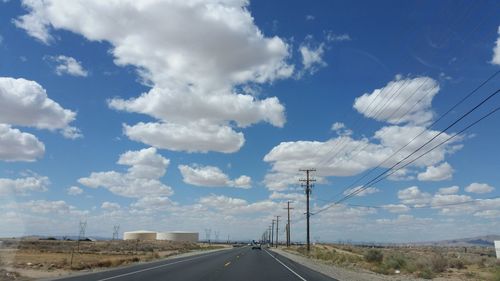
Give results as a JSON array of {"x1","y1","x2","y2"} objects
[{"x1": 284, "y1": 244, "x2": 500, "y2": 281}]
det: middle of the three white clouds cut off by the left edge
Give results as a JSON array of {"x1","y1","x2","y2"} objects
[{"x1": 0, "y1": 123, "x2": 45, "y2": 162}]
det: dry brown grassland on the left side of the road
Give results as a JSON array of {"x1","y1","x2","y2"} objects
[{"x1": 0, "y1": 236, "x2": 221, "y2": 281}]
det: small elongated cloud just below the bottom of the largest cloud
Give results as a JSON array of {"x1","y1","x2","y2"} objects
[{"x1": 179, "y1": 165, "x2": 251, "y2": 188}]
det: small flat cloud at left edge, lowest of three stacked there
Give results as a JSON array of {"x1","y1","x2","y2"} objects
[{"x1": 0, "y1": 174, "x2": 50, "y2": 196}]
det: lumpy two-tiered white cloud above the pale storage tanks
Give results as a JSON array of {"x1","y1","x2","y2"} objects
[{"x1": 78, "y1": 148, "x2": 173, "y2": 198}]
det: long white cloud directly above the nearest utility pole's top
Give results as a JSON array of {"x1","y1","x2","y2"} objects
[{"x1": 264, "y1": 125, "x2": 459, "y2": 191}]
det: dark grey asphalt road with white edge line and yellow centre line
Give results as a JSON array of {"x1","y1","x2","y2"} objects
[{"x1": 53, "y1": 247, "x2": 335, "y2": 281}]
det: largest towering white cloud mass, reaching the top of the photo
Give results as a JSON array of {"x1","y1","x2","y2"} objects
[{"x1": 15, "y1": 0, "x2": 294, "y2": 152}]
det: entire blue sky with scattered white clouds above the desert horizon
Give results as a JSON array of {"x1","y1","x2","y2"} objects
[{"x1": 0, "y1": 0, "x2": 500, "y2": 242}]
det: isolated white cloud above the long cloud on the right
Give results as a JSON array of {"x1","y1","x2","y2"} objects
[{"x1": 354, "y1": 77, "x2": 439, "y2": 125}]
